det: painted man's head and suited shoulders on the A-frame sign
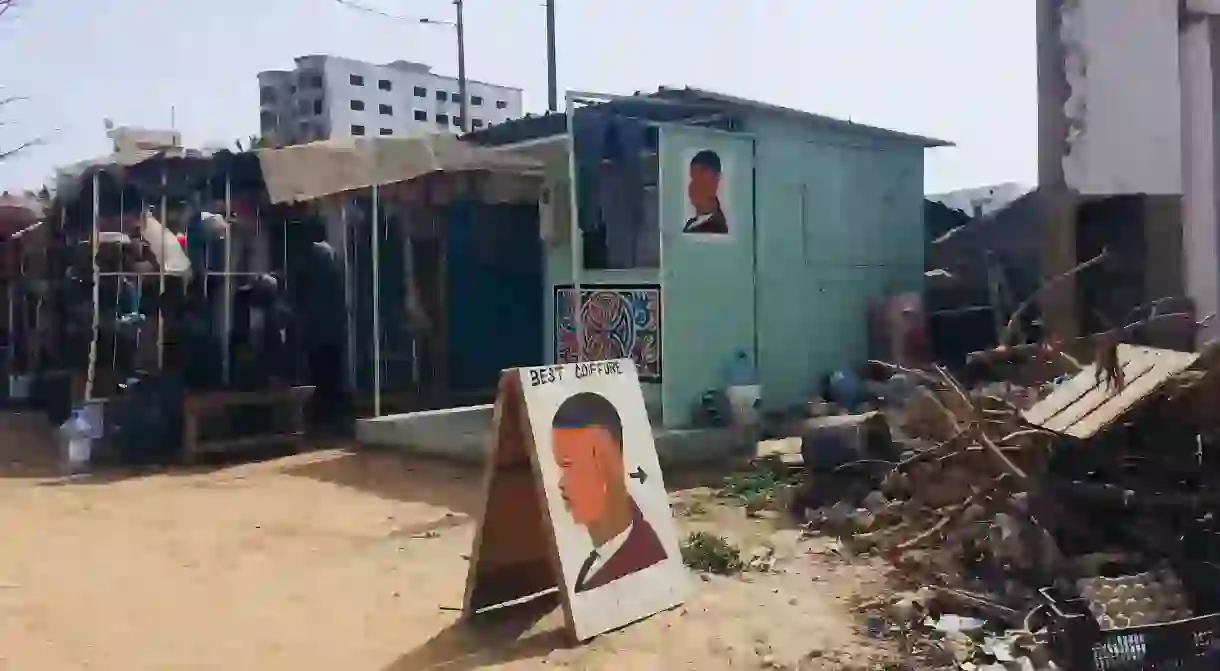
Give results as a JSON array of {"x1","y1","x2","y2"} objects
[{"x1": 551, "y1": 392, "x2": 666, "y2": 593}]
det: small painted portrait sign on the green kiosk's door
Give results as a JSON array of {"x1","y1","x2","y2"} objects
[{"x1": 682, "y1": 149, "x2": 736, "y2": 242}]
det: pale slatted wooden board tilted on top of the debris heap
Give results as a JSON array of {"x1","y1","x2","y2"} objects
[{"x1": 1024, "y1": 345, "x2": 1199, "y2": 440}]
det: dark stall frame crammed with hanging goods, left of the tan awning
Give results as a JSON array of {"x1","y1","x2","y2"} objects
[{"x1": 52, "y1": 149, "x2": 309, "y2": 461}]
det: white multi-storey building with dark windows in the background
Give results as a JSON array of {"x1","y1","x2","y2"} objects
[{"x1": 259, "y1": 56, "x2": 521, "y2": 144}]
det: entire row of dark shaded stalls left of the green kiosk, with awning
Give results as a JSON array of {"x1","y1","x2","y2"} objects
[{"x1": 25, "y1": 134, "x2": 543, "y2": 461}]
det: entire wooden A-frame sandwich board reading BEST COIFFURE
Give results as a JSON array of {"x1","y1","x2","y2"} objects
[{"x1": 465, "y1": 359, "x2": 688, "y2": 641}]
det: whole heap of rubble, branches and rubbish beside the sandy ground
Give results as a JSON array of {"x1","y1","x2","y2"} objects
[{"x1": 772, "y1": 348, "x2": 1220, "y2": 670}]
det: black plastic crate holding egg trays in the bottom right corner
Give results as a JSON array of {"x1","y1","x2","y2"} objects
[{"x1": 1041, "y1": 564, "x2": 1220, "y2": 671}]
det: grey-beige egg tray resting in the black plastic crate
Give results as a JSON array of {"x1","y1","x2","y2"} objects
[{"x1": 1076, "y1": 567, "x2": 1193, "y2": 631}]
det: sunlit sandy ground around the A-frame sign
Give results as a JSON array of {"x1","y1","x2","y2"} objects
[{"x1": 0, "y1": 415, "x2": 895, "y2": 671}]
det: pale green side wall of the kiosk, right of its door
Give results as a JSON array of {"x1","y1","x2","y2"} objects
[{"x1": 748, "y1": 115, "x2": 924, "y2": 407}]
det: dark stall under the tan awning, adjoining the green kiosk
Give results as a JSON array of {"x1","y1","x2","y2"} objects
[{"x1": 259, "y1": 133, "x2": 542, "y2": 416}]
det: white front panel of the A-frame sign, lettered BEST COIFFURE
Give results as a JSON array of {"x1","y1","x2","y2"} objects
[{"x1": 520, "y1": 359, "x2": 688, "y2": 641}]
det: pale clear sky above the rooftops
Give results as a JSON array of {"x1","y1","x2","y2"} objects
[{"x1": 0, "y1": 0, "x2": 1037, "y2": 192}]
